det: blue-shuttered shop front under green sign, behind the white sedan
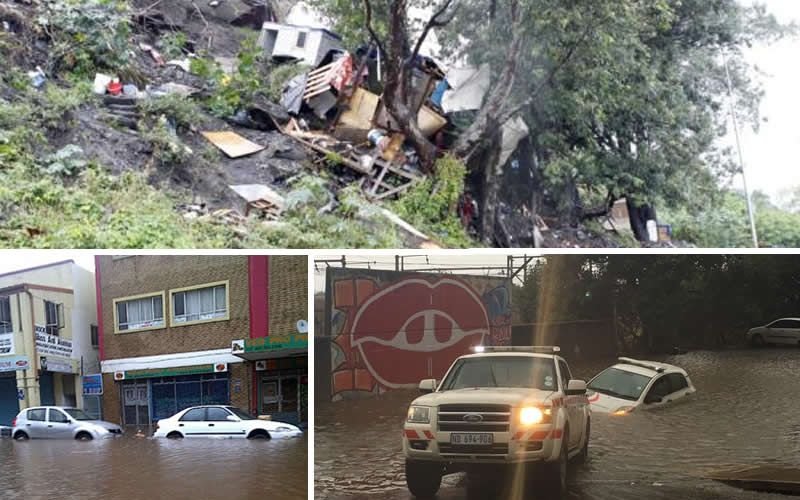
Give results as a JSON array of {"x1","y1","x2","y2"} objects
[{"x1": 114, "y1": 363, "x2": 230, "y2": 427}]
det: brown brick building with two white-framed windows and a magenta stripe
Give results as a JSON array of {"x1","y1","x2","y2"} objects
[{"x1": 96, "y1": 255, "x2": 307, "y2": 428}]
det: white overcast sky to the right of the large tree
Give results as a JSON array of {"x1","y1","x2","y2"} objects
[{"x1": 729, "y1": 0, "x2": 800, "y2": 198}]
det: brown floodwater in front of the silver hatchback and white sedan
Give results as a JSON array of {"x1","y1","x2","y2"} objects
[{"x1": 0, "y1": 436, "x2": 308, "y2": 500}]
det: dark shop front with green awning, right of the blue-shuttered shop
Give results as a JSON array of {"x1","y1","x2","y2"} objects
[{"x1": 231, "y1": 334, "x2": 308, "y2": 426}]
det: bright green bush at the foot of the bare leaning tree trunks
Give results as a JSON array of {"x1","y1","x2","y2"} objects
[{"x1": 391, "y1": 156, "x2": 478, "y2": 248}]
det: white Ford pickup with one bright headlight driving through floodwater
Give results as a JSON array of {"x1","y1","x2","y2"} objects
[{"x1": 403, "y1": 346, "x2": 591, "y2": 498}]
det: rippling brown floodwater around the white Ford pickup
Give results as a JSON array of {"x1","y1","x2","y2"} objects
[{"x1": 315, "y1": 349, "x2": 800, "y2": 500}]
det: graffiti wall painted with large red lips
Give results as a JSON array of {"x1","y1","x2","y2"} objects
[{"x1": 325, "y1": 269, "x2": 511, "y2": 401}]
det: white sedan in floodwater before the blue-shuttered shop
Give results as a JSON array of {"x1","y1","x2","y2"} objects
[{"x1": 153, "y1": 405, "x2": 303, "y2": 439}]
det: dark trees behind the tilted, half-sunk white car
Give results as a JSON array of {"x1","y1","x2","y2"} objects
[{"x1": 513, "y1": 254, "x2": 800, "y2": 353}]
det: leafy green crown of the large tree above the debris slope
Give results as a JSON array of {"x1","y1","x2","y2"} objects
[{"x1": 304, "y1": 0, "x2": 793, "y2": 240}]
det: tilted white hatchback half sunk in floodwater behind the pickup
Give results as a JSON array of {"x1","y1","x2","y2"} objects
[{"x1": 587, "y1": 358, "x2": 695, "y2": 415}]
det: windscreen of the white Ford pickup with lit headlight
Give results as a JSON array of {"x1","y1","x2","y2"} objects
[{"x1": 440, "y1": 356, "x2": 558, "y2": 391}]
